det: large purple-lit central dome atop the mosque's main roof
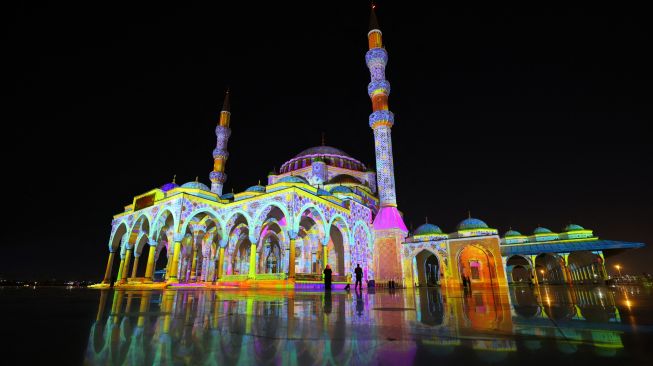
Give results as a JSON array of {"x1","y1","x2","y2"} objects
[{"x1": 281, "y1": 145, "x2": 367, "y2": 174}]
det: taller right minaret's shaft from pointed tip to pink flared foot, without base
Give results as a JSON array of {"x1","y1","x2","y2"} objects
[{"x1": 365, "y1": 3, "x2": 408, "y2": 232}]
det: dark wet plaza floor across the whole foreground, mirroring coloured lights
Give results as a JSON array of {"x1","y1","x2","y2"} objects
[{"x1": 0, "y1": 286, "x2": 653, "y2": 365}]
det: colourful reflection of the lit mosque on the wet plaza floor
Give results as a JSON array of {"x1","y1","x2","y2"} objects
[{"x1": 85, "y1": 287, "x2": 623, "y2": 365}]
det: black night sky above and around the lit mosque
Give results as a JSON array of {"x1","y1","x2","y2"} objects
[{"x1": 6, "y1": 1, "x2": 653, "y2": 280}]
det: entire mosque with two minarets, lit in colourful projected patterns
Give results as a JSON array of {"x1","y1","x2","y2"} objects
[{"x1": 99, "y1": 10, "x2": 644, "y2": 288}]
